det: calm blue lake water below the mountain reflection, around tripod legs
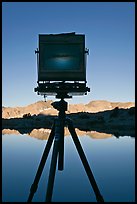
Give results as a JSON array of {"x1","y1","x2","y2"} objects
[{"x1": 2, "y1": 135, "x2": 135, "y2": 202}]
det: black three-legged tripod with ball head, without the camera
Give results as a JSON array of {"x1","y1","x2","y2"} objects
[{"x1": 28, "y1": 99, "x2": 104, "y2": 202}]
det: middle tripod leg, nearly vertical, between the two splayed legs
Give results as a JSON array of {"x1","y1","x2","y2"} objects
[{"x1": 45, "y1": 135, "x2": 59, "y2": 202}]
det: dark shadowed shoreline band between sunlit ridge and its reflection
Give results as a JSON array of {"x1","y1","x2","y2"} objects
[{"x1": 2, "y1": 107, "x2": 135, "y2": 137}]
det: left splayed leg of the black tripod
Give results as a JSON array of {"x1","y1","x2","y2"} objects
[{"x1": 27, "y1": 123, "x2": 55, "y2": 202}]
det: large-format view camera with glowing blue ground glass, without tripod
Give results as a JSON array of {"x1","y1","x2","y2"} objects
[{"x1": 34, "y1": 32, "x2": 90, "y2": 98}]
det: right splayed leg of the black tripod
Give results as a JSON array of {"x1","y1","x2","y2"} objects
[{"x1": 68, "y1": 120, "x2": 104, "y2": 202}]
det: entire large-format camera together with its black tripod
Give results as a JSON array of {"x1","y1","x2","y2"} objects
[{"x1": 28, "y1": 33, "x2": 104, "y2": 202}]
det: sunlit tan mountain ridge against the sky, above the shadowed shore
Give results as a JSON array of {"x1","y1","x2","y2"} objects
[{"x1": 2, "y1": 100, "x2": 135, "y2": 119}]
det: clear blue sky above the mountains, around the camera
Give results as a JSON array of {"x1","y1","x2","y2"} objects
[{"x1": 2, "y1": 2, "x2": 135, "y2": 106}]
